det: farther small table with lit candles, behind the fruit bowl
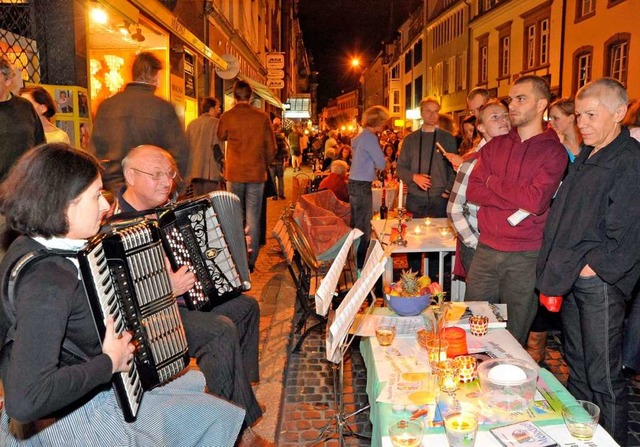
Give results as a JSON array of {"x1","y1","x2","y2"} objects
[{"x1": 371, "y1": 217, "x2": 464, "y2": 301}]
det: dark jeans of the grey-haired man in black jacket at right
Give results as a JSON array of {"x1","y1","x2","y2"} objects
[{"x1": 564, "y1": 276, "x2": 628, "y2": 446}]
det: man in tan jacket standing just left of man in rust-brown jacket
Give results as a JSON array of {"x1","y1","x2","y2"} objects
[{"x1": 185, "y1": 97, "x2": 224, "y2": 196}]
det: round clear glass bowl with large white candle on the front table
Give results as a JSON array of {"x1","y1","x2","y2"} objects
[{"x1": 478, "y1": 358, "x2": 538, "y2": 413}]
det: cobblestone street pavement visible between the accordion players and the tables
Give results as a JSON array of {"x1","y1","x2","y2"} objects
[{"x1": 251, "y1": 168, "x2": 640, "y2": 447}]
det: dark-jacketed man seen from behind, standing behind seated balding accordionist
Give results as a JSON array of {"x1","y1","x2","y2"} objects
[{"x1": 89, "y1": 52, "x2": 189, "y2": 194}]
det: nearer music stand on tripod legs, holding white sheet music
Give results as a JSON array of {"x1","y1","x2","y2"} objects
[{"x1": 310, "y1": 240, "x2": 389, "y2": 447}]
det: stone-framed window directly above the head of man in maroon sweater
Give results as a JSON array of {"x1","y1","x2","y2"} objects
[{"x1": 521, "y1": 3, "x2": 551, "y2": 70}]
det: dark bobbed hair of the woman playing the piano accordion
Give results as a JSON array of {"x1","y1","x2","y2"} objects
[{"x1": 0, "y1": 143, "x2": 102, "y2": 238}]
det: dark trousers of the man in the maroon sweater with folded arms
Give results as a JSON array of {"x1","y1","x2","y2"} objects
[{"x1": 464, "y1": 243, "x2": 538, "y2": 346}]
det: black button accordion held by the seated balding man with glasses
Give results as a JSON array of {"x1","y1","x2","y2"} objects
[{"x1": 158, "y1": 191, "x2": 251, "y2": 310}]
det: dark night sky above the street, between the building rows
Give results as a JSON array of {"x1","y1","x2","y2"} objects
[{"x1": 298, "y1": 0, "x2": 422, "y2": 109}]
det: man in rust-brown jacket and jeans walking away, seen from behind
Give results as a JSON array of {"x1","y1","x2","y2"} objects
[{"x1": 218, "y1": 81, "x2": 276, "y2": 271}]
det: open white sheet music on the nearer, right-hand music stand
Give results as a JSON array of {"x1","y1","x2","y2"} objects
[{"x1": 326, "y1": 241, "x2": 387, "y2": 362}]
